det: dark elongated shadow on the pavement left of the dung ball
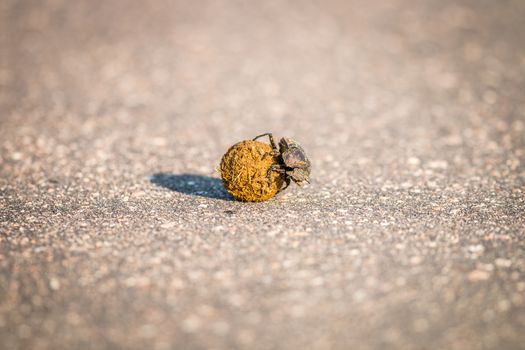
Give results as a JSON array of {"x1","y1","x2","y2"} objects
[{"x1": 149, "y1": 173, "x2": 229, "y2": 201}]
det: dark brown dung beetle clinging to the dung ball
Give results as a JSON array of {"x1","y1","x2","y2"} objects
[{"x1": 253, "y1": 132, "x2": 311, "y2": 191}]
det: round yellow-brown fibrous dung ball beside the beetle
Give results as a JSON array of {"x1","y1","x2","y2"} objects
[{"x1": 220, "y1": 141, "x2": 284, "y2": 202}]
